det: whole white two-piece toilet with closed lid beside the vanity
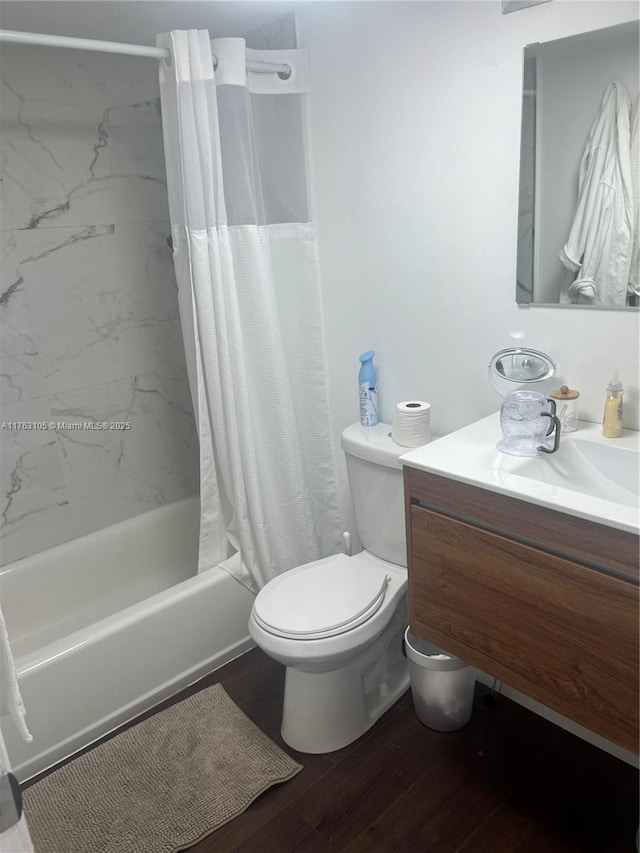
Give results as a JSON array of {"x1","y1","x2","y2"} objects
[{"x1": 249, "y1": 423, "x2": 409, "y2": 753}]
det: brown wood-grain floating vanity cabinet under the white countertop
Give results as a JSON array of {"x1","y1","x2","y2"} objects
[{"x1": 404, "y1": 467, "x2": 640, "y2": 753}]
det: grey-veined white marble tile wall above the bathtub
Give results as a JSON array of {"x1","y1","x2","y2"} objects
[{"x1": 0, "y1": 45, "x2": 198, "y2": 564}]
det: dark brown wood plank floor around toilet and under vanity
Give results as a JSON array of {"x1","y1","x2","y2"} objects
[{"x1": 25, "y1": 649, "x2": 639, "y2": 853}]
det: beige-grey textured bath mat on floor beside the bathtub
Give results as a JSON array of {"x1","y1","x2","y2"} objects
[{"x1": 23, "y1": 684, "x2": 302, "y2": 853}]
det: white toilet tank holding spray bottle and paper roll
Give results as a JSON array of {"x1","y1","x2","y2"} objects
[{"x1": 342, "y1": 423, "x2": 408, "y2": 566}]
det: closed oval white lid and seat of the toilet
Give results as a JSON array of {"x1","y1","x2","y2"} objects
[{"x1": 253, "y1": 552, "x2": 390, "y2": 640}]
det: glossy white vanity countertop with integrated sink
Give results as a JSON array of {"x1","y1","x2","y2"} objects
[{"x1": 400, "y1": 412, "x2": 640, "y2": 533}]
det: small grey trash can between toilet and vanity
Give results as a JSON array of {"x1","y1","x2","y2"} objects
[{"x1": 404, "y1": 628, "x2": 476, "y2": 732}]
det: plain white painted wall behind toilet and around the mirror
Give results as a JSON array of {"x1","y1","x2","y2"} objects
[{"x1": 298, "y1": 0, "x2": 639, "y2": 524}]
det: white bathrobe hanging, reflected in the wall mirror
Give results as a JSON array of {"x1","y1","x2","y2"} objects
[{"x1": 560, "y1": 81, "x2": 634, "y2": 305}]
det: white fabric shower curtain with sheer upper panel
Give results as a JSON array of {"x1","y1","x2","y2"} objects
[{"x1": 158, "y1": 30, "x2": 341, "y2": 592}]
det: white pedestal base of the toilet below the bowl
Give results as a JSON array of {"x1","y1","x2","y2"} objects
[{"x1": 281, "y1": 601, "x2": 409, "y2": 754}]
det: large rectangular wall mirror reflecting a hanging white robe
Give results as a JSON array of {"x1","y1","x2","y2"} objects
[{"x1": 516, "y1": 21, "x2": 640, "y2": 309}]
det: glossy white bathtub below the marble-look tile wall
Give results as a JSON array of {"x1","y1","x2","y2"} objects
[{"x1": 0, "y1": 498, "x2": 254, "y2": 781}]
